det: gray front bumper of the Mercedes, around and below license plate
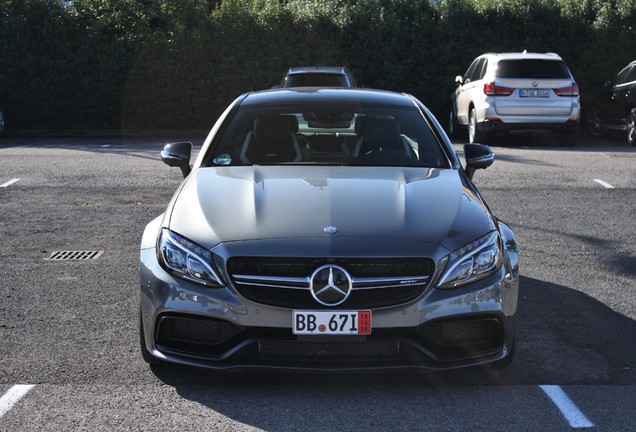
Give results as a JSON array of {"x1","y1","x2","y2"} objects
[{"x1": 141, "y1": 248, "x2": 518, "y2": 370}]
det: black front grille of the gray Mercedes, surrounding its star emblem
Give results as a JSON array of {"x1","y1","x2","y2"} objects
[{"x1": 228, "y1": 257, "x2": 435, "y2": 309}]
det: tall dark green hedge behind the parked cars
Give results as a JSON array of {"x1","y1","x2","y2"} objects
[{"x1": 0, "y1": 0, "x2": 636, "y2": 130}]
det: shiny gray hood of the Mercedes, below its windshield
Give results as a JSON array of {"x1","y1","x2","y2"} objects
[{"x1": 167, "y1": 166, "x2": 494, "y2": 250}]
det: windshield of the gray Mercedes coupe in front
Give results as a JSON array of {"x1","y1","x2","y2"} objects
[{"x1": 207, "y1": 104, "x2": 449, "y2": 168}]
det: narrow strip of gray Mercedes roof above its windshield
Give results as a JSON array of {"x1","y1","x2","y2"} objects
[{"x1": 241, "y1": 87, "x2": 415, "y2": 107}]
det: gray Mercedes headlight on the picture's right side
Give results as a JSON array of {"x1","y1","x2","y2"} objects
[{"x1": 438, "y1": 231, "x2": 501, "y2": 288}]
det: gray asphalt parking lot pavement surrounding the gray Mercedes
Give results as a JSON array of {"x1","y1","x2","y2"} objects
[{"x1": 0, "y1": 133, "x2": 636, "y2": 431}]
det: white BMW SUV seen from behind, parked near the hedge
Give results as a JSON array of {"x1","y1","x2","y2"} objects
[{"x1": 449, "y1": 51, "x2": 581, "y2": 145}]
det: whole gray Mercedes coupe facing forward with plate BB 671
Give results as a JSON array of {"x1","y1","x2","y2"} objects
[{"x1": 140, "y1": 88, "x2": 519, "y2": 370}]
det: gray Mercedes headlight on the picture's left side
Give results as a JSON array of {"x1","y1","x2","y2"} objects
[{"x1": 157, "y1": 228, "x2": 224, "y2": 287}]
